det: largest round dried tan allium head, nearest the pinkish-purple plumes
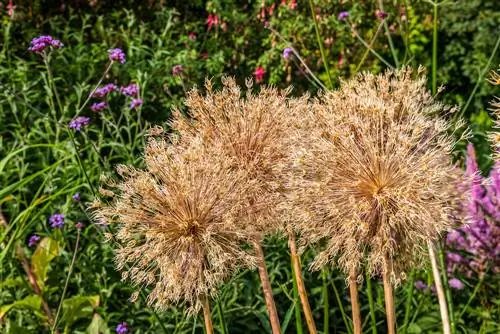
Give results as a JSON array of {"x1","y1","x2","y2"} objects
[{"x1": 289, "y1": 69, "x2": 461, "y2": 283}]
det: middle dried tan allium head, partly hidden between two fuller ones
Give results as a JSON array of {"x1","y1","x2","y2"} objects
[{"x1": 168, "y1": 78, "x2": 306, "y2": 232}]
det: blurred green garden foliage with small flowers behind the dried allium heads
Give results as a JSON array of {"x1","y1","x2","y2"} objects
[{"x1": 0, "y1": 0, "x2": 500, "y2": 333}]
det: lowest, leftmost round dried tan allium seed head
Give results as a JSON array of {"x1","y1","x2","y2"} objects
[{"x1": 95, "y1": 140, "x2": 253, "y2": 312}]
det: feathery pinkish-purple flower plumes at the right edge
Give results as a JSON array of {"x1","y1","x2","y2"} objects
[{"x1": 446, "y1": 144, "x2": 500, "y2": 278}]
